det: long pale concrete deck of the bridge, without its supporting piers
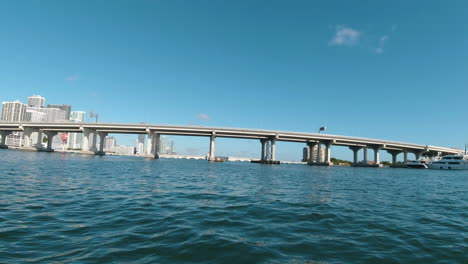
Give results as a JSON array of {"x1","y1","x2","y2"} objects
[{"x1": 0, "y1": 122, "x2": 462, "y2": 154}]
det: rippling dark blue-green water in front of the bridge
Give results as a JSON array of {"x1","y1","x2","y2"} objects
[{"x1": 0, "y1": 150, "x2": 468, "y2": 263}]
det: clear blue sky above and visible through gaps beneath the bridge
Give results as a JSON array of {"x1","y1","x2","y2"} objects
[{"x1": 0, "y1": 0, "x2": 468, "y2": 159}]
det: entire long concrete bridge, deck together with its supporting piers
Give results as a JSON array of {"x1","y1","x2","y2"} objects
[{"x1": 0, "y1": 122, "x2": 462, "y2": 167}]
